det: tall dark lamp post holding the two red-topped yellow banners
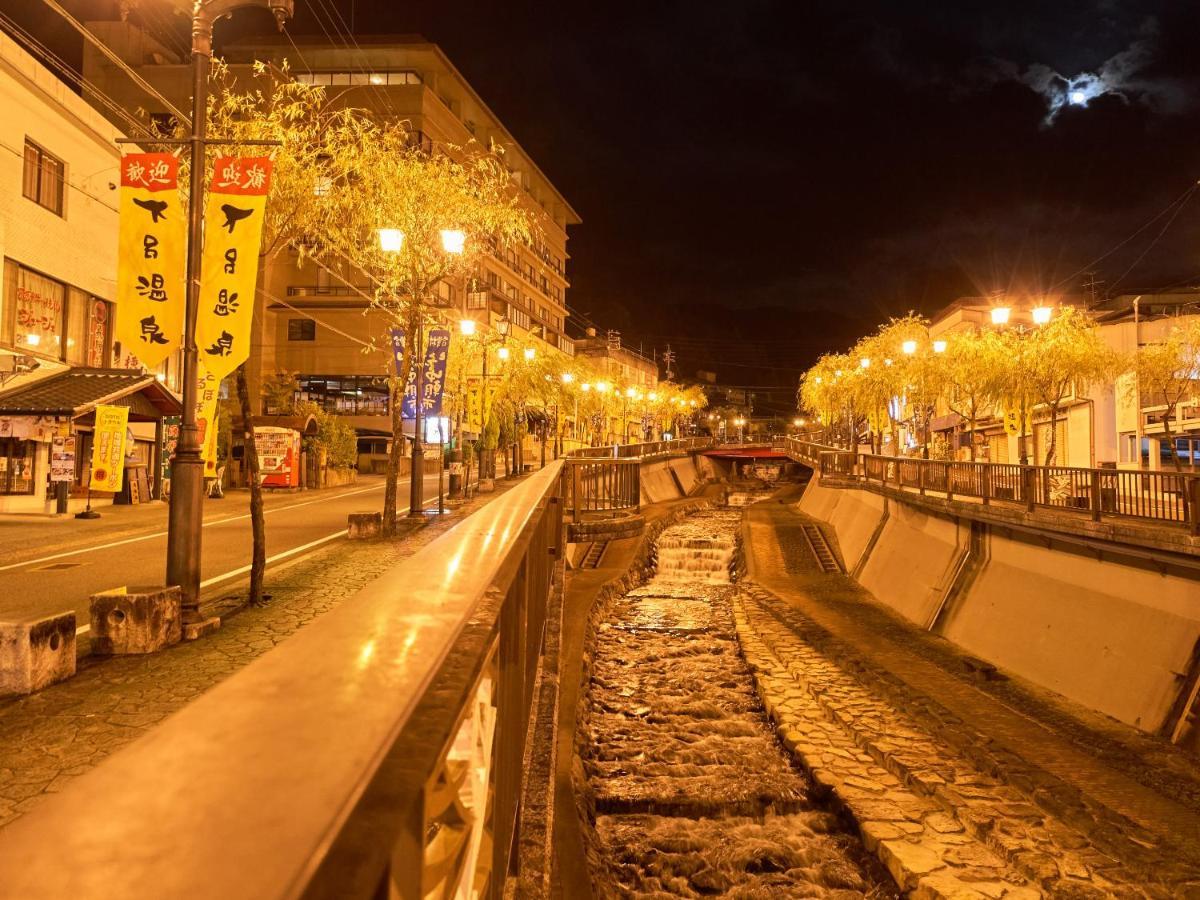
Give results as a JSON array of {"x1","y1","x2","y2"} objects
[{"x1": 167, "y1": 0, "x2": 293, "y2": 623}]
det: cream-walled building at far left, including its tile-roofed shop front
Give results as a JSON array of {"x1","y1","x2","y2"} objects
[{"x1": 0, "y1": 34, "x2": 179, "y2": 512}]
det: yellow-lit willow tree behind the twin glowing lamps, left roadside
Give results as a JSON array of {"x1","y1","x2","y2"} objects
[{"x1": 329, "y1": 126, "x2": 535, "y2": 534}]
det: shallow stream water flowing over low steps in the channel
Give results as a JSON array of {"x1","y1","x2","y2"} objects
[{"x1": 583, "y1": 510, "x2": 896, "y2": 900}]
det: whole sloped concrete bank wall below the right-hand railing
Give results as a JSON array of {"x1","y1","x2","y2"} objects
[{"x1": 797, "y1": 479, "x2": 1200, "y2": 732}]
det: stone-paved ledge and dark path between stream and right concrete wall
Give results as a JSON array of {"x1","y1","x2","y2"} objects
[{"x1": 736, "y1": 502, "x2": 1200, "y2": 898}]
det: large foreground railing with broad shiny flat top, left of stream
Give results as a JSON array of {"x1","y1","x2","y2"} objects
[{"x1": 0, "y1": 462, "x2": 564, "y2": 900}]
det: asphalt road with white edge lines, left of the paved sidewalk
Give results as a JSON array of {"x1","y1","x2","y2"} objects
[{"x1": 0, "y1": 475, "x2": 448, "y2": 634}]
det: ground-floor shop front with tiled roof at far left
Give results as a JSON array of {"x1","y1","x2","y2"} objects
[{"x1": 0, "y1": 368, "x2": 181, "y2": 514}]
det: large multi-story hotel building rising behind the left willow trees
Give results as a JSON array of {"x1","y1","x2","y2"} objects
[{"x1": 84, "y1": 22, "x2": 580, "y2": 460}]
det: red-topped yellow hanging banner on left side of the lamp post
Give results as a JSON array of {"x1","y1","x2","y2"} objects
[{"x1": 116, "y1": 154, "x2": 187, "y2": 368}]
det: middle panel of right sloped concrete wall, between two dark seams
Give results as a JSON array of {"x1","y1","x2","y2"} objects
[{"x1": 858, "y1": 503, "x2": 971, "y2": 628}]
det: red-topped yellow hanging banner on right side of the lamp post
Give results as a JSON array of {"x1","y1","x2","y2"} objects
[{"x1": 196, "y1": 156, "x2": 271, "y2": 382}]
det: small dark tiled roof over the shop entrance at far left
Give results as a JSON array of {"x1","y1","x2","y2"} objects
[{"x1": 0, "y1": 368, "x2": 184, "y2": 421}]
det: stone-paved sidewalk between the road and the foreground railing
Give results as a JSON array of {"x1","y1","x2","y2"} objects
[{"x1": 0, "y1": 481, "x2": 516, "y2": 827}]
